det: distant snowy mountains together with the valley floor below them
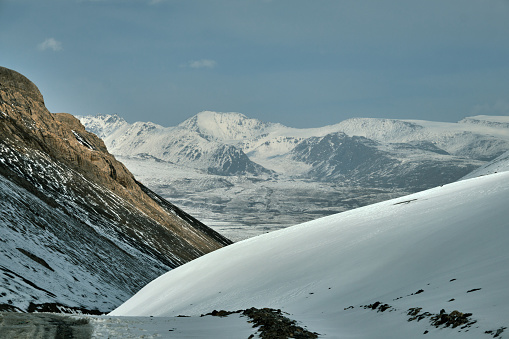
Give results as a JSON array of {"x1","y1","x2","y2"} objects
[{"x1": 80, "y1": 111, "x2": 509, "y2": 240}]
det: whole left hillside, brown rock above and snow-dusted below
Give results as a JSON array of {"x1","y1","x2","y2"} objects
[{"x1": 0, "y1": 67, "x2": 231, "y2": 312}]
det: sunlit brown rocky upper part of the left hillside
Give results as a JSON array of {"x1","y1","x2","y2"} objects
[{"x1": 0, "y1": 67, "x2": 231, "y2": 253}]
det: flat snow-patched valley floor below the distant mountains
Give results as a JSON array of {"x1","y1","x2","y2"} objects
[{"x1": 117, "y1": 156, "x2": 406, "y2": 241}]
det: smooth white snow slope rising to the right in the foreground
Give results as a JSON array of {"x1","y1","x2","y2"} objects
[{"x1": 111, "y1": 172, "x2": 509, "y2": 338}]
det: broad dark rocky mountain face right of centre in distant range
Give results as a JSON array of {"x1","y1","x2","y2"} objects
[{"x1": 291, "y1": 133, "x2": 476, "y2": 192}]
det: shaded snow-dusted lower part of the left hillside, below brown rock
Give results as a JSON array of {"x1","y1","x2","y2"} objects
[{"x1": 0, "y1": 159, "x2": 163, "y2": 312}]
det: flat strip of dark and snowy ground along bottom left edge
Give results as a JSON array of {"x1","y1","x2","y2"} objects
[{"x1": 0, "y1": 312, "x2": 315, "y2": 339}]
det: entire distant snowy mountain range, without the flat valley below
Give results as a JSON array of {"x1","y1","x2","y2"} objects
[{"x1": 81, "y1": 112, "x2": 509, "y2": 191}]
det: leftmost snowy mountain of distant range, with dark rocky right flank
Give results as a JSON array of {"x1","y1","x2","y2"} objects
[{"x1": 81, "y1": 115, "x2": 270, "y2": 175}]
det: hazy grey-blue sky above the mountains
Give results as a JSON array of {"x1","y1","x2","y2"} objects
[{"x1": 0, "y1": 0, "x2": 509, "y2": 128}]
